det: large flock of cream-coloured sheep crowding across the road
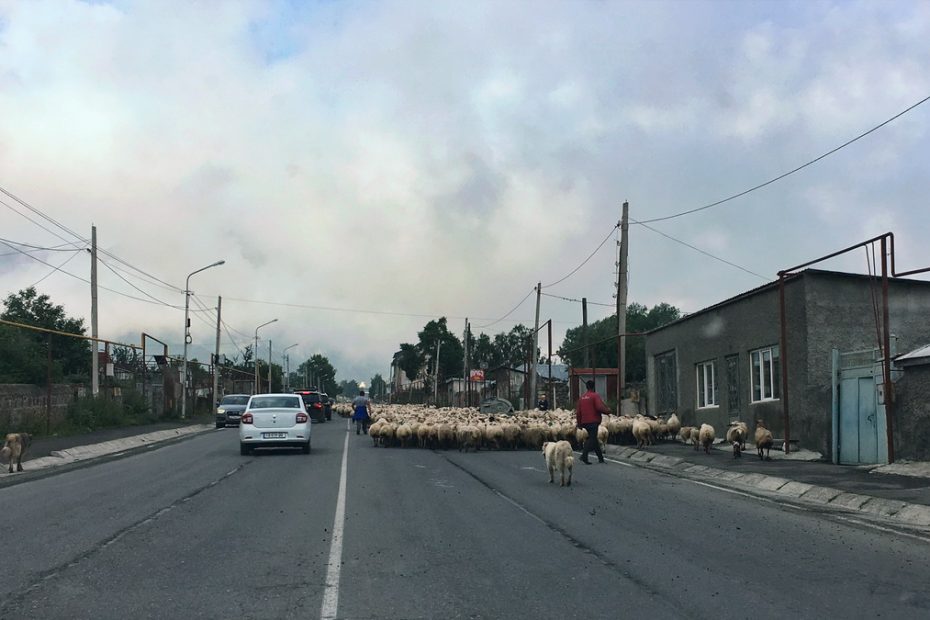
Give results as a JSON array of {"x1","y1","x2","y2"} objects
[{"x1": 336, "y1": 405, "x2": 773, "y2": 459}]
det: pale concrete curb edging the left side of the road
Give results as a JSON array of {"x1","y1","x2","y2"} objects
[{"x1": 0, "y1": 424, "x2": 215, "y2": 486}]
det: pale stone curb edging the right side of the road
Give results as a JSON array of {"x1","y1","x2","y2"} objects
[{"x1": 605, "y1": 445, "x2": 930, "y2": 528}]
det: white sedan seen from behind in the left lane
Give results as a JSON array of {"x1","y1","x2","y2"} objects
[{"x1": 239, "y1": 394, "x2": 310, "y2": 455}]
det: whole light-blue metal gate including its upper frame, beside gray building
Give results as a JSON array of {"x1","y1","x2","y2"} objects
[{"x1": 833, "y1": 349, "x2": 888, "y2": 465}]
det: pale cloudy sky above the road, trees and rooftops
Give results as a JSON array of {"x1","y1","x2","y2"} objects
[{"x1": 0, "y1": 0, "x2": 930, "y2": 382}]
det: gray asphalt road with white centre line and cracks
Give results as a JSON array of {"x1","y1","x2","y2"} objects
[{"x1": 0, "y1": 420, "x2": 930, "y2": 619}]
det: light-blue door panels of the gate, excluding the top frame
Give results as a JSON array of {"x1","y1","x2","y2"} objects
[{"x1": 838, "y1": 368, "x2": 882, "y2": 465}]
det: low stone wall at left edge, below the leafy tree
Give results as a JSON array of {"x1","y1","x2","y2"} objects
[{"x1": 0, "y1": 384, "x2": 84, "y2": 433}]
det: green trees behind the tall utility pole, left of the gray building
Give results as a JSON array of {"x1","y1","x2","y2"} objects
[{"x1": 558, "y1": 302, "x2": 681, "y2": 382}]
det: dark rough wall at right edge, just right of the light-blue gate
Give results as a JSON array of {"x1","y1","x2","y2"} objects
[{"x1": 894, "y1": 365, "x2": 930, "y2": 461}]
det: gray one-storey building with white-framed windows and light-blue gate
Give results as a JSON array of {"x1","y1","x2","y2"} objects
[{"x1": 646, "y1": 269, "x2": 930, "y2": 463}]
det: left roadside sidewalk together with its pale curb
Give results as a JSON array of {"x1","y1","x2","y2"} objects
[{"x1": 0, "y1": 421, "x2": 215, "y2": 483}]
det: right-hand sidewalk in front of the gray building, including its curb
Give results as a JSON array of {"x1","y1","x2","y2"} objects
[{"x1": 607, "y1": 441, "x2": 930, "y2": 531}]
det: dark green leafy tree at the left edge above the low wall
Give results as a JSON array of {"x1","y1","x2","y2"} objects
[{"x1": 0, "y1": 287, "x2": 91, "y2": 384}]
